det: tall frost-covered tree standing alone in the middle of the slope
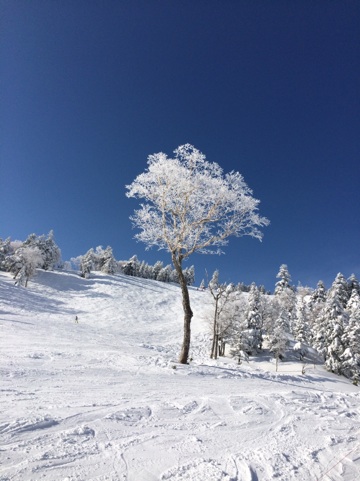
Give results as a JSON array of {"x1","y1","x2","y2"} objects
[{"x1": 127, "y1": 144, "x2": 269, "y2": 364}]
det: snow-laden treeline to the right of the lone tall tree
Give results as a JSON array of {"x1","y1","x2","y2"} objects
[{"x1": 209, "y1": 265, "x2": 360, "y2": 384}]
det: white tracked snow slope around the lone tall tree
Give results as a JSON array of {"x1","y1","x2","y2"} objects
[{"x1": 0, "y1": 271, "x2": 360, "y2": 481}]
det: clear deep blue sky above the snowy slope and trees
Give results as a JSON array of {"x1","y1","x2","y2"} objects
[{"x1": 0, "y1": 0, "x2": 360, "y2": 289}]
